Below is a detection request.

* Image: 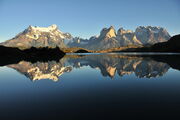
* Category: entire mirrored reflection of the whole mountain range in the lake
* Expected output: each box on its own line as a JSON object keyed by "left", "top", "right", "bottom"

{"left": 7, "top": 55, "right": 170, "bottom": 81}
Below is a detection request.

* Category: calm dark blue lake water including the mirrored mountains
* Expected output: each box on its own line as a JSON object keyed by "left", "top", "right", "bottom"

{"left": 0, "top": 54, "right": 180, "bottom": 120}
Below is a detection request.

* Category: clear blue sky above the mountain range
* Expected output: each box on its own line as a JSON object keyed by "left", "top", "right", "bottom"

{"left": 0, "top": 0, "right": 180, "bottom": 41}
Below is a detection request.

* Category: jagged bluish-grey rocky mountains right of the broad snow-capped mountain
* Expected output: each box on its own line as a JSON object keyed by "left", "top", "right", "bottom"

{"left": 68, "top": 26, "right": 171, "bottom": 50}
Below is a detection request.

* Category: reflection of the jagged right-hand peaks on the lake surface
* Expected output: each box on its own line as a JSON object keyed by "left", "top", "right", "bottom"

{"left": 68, "top": 55, "right": 170, "bottom": 78}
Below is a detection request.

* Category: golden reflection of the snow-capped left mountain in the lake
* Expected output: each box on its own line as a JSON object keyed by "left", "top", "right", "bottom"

{"left": 8, "top": 61, "right": 72, "bottom": 81}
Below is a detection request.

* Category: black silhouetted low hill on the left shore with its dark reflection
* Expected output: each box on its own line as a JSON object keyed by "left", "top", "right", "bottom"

{"left": 0, "top": 46, "right": 65, "bottom": 66}
